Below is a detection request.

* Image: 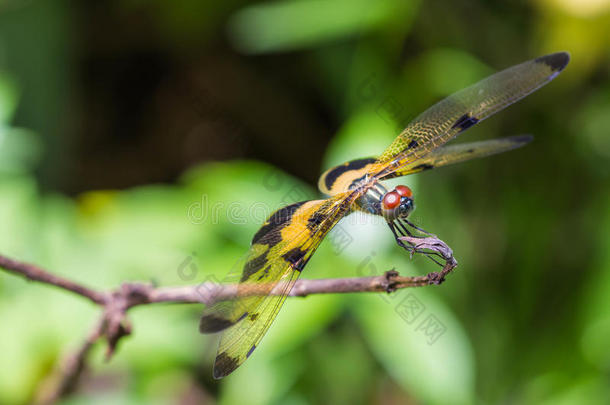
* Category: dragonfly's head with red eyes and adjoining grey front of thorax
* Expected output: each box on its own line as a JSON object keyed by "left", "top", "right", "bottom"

{"left": 357, "top": 183, "right": 415, "bottom": 221}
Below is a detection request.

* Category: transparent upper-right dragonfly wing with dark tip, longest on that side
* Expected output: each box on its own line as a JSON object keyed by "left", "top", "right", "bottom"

{"left": 372, "top": 52, "right": 570, "bottom": 179}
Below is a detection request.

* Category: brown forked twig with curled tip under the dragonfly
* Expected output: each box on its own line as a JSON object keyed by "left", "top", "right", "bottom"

{"left": 0, "top": 236, "right": 457, "bottom": 404}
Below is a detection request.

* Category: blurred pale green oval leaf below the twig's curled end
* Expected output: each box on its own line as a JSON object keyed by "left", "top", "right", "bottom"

{"left": 354, "top": 289, "right": 475, "bottom": 404}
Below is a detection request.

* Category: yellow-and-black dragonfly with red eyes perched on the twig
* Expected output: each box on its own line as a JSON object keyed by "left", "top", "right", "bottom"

{"left": 199, "top": 52, "right": 570, "bottom": 379}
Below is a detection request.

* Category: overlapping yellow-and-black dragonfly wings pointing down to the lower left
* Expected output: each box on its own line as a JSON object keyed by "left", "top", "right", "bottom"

{"left": 199, "top": 193, "right": 357, "bottom": 378}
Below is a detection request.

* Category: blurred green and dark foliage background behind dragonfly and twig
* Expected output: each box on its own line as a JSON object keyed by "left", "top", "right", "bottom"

{"left": 0, "top": 0, "right": 610, "bottom": 405}
